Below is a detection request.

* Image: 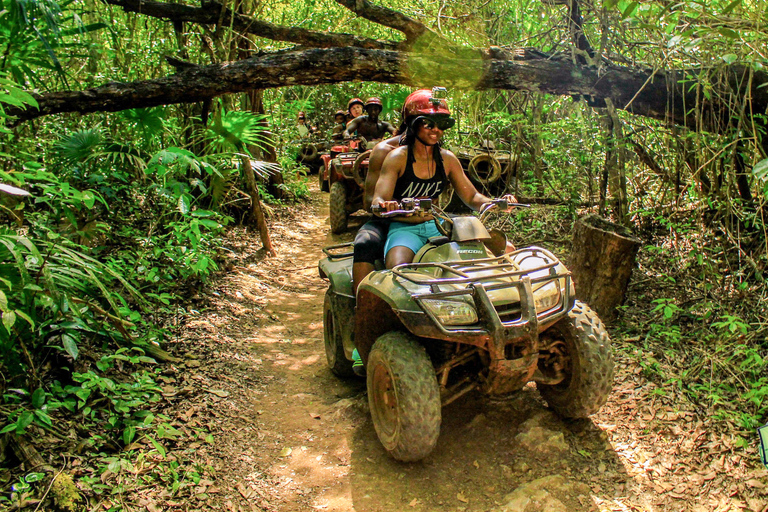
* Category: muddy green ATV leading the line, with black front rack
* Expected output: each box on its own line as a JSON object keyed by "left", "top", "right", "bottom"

{"left": 319, "top": 200, "right": 613, "bottom": 461}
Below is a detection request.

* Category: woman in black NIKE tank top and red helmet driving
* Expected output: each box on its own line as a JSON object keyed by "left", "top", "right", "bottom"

{"left": 372, "top": 87, "right": 517, "bottom": 268}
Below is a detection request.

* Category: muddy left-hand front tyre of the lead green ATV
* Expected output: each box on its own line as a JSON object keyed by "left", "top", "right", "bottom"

{"left": 366, "top": 331, "right": 441, "bottom": 461}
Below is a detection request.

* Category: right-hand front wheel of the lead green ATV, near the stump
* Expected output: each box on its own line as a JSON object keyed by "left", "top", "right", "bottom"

{"left": 537, "top": 301, "right": 613, "bottom": 418}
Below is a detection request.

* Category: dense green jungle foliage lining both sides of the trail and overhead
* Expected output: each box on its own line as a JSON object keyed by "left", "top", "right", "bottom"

{"left": 0, "top": 0, "right": 768, "bottom": 501}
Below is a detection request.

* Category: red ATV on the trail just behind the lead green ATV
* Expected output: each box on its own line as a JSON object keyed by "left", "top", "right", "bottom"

{"left": 320, "top": 137, "right": 378, "bottom": 234}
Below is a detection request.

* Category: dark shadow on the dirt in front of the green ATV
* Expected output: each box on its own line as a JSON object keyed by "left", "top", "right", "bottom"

{"left": 350, "top": 387, "right": 628, "bottom": 512}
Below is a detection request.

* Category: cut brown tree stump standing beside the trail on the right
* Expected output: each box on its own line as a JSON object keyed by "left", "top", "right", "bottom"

{"left": 570, "top": 215, "right": 641, "bottom": 321}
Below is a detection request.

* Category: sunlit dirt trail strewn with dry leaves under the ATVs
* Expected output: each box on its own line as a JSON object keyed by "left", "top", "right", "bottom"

{"left": 166, "top": 183, "right": 768, "bottom": 512}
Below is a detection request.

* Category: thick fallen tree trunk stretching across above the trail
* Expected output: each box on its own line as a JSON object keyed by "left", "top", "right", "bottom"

{"left": 7, "top": 47, "right": 768, "bottom": 147}
